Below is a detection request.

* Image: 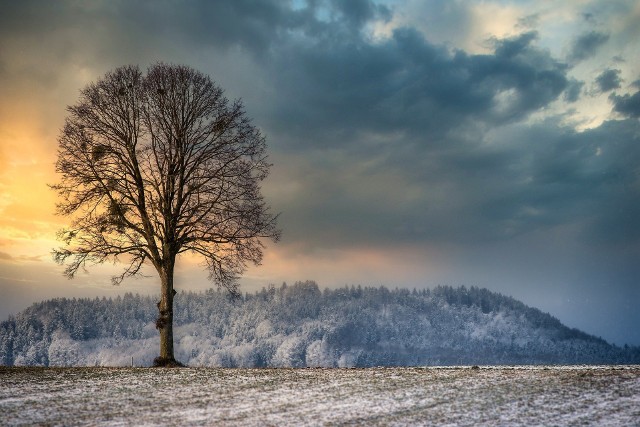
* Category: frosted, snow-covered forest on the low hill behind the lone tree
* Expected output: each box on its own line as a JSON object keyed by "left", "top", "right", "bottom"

{"left": 0, "top": 282, "right": 640, "bottom": 367}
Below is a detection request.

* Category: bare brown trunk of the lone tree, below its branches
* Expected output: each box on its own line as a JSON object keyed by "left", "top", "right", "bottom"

{"left": 153, "top": 259, "right": 182, "bottom": 366}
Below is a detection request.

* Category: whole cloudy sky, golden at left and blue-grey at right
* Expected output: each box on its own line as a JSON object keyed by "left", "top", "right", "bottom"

{"left": 0, "top": 0, "right": 640, "bottom": 345}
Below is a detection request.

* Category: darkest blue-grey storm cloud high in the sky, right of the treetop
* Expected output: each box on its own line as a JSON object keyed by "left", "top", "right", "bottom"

{"left": 274, "top": 28, "right": 569, "bottom": 149}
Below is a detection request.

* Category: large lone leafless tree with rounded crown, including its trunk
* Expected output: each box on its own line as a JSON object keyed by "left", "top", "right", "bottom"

{"left": 52, "top": 63, "right": 280, "bottom": 366}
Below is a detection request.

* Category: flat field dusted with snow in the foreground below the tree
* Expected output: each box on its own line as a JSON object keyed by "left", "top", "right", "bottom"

{"left": 0, "top": 366, "right": 640, "bottom": 426}
